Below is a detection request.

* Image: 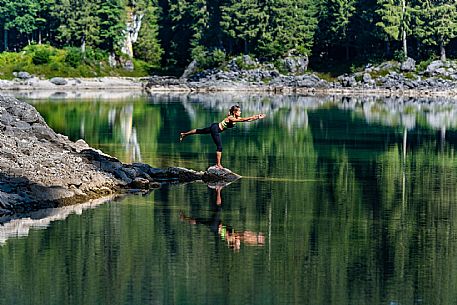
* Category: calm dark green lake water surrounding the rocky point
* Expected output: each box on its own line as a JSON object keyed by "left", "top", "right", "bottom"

{"left": 0, "top": 94, "right": 457, "bottom": 305}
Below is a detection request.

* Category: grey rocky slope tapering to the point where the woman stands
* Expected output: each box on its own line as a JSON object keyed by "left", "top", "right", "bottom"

{"left": 0, "top": 94, "right": 240, "bottom": 216}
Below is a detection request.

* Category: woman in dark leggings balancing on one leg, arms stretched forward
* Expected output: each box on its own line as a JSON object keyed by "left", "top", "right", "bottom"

{"left": 179, "top": 105, "right": 265, "bottom": 168}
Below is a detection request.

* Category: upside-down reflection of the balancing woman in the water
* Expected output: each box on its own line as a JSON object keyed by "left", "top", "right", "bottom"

{"left": 179, "top": 184, "right": 265, "bottom": 250}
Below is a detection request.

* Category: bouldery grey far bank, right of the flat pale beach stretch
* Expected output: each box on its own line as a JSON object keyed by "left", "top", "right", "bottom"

{"left": 145, "top": 57, "right": 457, "bottom": 97}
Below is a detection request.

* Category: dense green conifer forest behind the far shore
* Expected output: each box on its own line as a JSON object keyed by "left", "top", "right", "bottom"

{"left": 0, "top": 0, "right": 457, "bottom": 73}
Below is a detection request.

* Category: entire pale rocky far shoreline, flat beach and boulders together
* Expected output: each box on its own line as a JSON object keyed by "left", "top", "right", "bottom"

{"left": 4, "top": 55, "right": 457, "bottom": 98}
